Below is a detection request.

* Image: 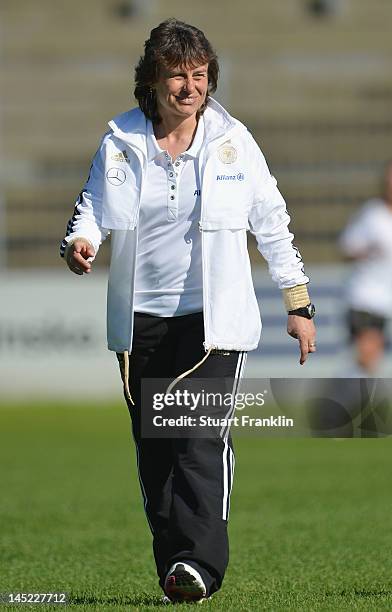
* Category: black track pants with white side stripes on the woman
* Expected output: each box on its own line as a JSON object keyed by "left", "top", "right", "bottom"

{"left": 118, "top": 313, "right": 246, "bottom": 594}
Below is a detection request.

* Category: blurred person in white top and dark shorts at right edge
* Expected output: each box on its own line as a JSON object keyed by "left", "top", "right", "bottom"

{"left": 340, "top": 163, "right": 392, "bottom": 377}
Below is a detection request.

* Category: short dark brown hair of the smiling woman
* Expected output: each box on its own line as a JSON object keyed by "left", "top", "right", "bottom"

{"left": 134, "top": 18, "right": 219, "bottom": 123}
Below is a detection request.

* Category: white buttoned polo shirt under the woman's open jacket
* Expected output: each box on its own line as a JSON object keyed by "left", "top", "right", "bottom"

{"left": 135, "top": 117, "right": 204, "bottom": 317}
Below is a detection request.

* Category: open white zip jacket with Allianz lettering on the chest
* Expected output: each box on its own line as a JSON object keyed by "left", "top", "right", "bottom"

{"left": 62, "top": 98, "right": 309, "bottom": 352}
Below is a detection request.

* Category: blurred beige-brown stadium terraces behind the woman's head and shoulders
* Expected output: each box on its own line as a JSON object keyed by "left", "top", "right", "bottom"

{"left": 0, "top": 0, "right": 392, "bottom": 268}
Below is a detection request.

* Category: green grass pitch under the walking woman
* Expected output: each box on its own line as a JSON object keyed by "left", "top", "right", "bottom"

{"left": 0, "top": 406, "right": 392, "bottom": 612}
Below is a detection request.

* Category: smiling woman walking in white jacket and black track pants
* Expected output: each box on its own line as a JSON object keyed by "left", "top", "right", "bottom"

{"left": 62, "top": 19, "right": 315, "bottom": 601}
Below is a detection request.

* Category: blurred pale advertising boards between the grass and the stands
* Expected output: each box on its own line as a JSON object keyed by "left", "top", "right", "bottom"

{"left": 0, "top": 265, "right": 392, "bottom": 403}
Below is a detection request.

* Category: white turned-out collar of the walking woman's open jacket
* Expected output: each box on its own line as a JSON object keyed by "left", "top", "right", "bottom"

{"left": 109, "top": 97, "right": 246, "bottom": 155}
